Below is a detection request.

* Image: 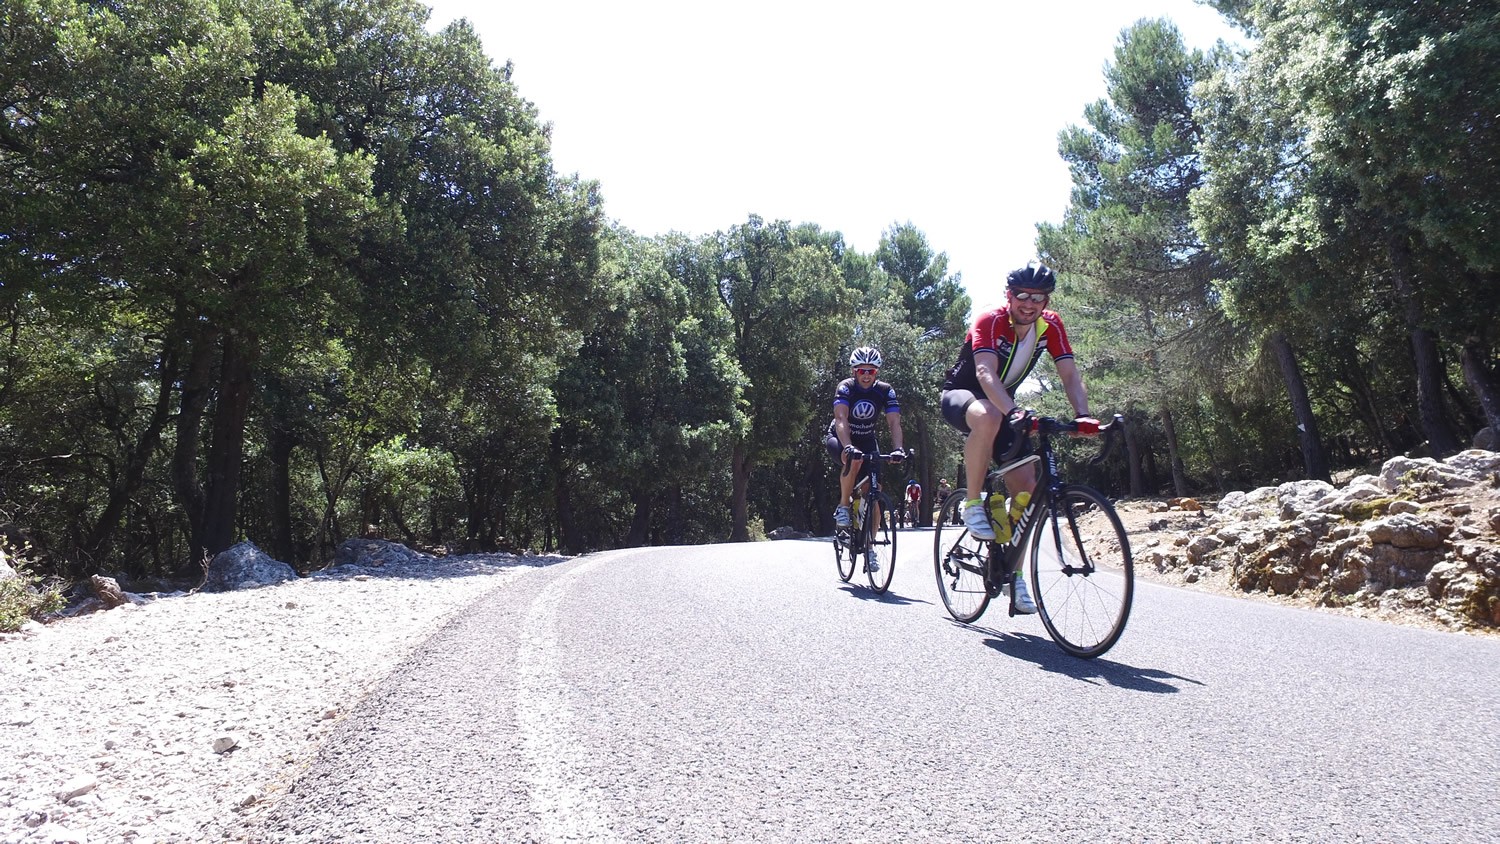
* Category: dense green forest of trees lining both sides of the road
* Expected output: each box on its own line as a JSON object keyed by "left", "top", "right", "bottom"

{"left": 0, "top": 0, "right": 1500, "bottom": 579}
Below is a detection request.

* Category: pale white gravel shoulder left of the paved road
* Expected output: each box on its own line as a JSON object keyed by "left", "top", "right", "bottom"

{"left": 0, "top": 555, "right": 563, "bottom": 844}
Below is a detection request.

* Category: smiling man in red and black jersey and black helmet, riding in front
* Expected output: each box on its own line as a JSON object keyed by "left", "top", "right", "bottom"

{"left": 942, "top": 262, "right": 1098, "bottom": 613}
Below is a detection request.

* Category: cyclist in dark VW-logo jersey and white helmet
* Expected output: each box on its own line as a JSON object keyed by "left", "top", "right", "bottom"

{"left": 824, "top": 346, "right": 906, "bottom": 528}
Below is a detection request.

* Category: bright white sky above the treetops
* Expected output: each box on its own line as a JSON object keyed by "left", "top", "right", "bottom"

{"left": 428, "top": 0, "right": 1242, "bottom": 307}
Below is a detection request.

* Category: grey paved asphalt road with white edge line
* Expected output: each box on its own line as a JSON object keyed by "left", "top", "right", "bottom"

{"left": 251, "top": 531, "right": 1500, "bottom": 843}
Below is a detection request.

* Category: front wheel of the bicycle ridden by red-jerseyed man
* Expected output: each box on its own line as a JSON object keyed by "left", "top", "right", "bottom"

{"left": 1031, "top": 484, "right": 1136, "bottom": 660}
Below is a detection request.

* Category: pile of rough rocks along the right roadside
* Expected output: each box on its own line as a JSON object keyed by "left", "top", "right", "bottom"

{"left": 1122, "top": 450, "right": 1500, "bottom": 631}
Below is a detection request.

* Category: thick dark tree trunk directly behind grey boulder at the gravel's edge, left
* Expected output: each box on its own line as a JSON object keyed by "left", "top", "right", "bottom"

{"left": 203, "top": 331, "right": 258, "bottom": 555}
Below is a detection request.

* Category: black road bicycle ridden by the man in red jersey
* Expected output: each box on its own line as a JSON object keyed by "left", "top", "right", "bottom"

{"left": 933, "top": 414, "right": 1136, "bottom": 658}
